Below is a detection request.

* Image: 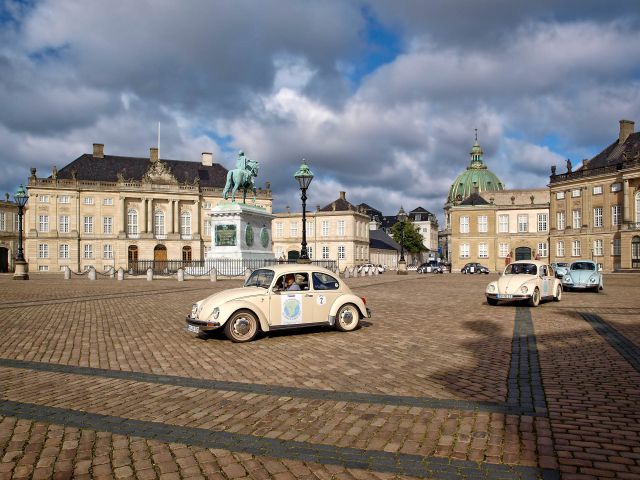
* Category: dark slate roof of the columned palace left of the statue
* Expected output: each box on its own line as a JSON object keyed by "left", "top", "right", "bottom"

{"left": 58, "top": 153, "right": 227, "bottom": 188}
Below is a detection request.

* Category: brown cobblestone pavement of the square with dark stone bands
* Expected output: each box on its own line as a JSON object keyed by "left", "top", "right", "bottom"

{"left": 0, "top": 274, "right": 640, "bottom": 480}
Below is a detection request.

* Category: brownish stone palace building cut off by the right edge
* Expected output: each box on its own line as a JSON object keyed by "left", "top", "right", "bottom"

{"left": 549, "top": 120, "right": 640, "bottom": 272}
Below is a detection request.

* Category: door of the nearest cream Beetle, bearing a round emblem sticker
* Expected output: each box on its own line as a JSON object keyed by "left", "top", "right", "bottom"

{"left": 269, "top": 272, "right": 315, "bottom": 328}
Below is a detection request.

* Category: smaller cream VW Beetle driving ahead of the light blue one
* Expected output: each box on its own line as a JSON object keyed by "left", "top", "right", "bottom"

{"left": 485, "top": 260, "right": 562, "bottom": 307}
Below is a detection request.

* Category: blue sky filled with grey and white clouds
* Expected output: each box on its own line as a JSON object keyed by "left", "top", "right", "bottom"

{"left": 0, "top": 0, "right": 640, "bottom": 216}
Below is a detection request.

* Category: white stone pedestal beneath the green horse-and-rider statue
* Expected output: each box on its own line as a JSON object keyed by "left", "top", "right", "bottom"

{"left": 205, "top": 203, "right": 275, "bottom": 260}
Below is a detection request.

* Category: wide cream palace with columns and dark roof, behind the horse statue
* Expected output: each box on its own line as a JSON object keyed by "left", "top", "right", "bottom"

{"left": 24, "top": 144, "right": 272, "bottom": 272}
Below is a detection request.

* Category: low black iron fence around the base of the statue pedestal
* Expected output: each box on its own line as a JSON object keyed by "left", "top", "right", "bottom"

{"left": 127, "top": 258, "right": 337, "bottom": 277}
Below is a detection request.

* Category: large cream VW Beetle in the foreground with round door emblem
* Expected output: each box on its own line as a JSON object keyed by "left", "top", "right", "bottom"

{"left": 186, "top": 264, "right": 371, "bottom": 342}
